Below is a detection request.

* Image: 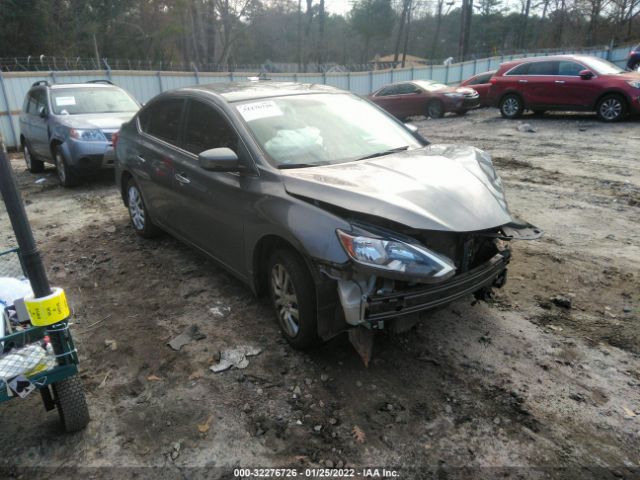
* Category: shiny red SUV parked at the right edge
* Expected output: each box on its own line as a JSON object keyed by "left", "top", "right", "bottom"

{"left": 489, "top": 55, "right": 640, "bottom": 122}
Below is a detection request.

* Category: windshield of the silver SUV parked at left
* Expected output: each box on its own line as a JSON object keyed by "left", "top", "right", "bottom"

{"left": 51, "top": 87, "right": 138, "bottom": 115}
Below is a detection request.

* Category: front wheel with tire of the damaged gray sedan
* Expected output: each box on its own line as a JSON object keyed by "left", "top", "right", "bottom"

{"left": 267, "top": 250, "right": 320, "bottom": 350}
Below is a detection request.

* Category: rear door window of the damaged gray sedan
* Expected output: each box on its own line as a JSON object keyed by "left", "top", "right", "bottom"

{"left": 138, "top": 98, "right": 185, "bottom": 145}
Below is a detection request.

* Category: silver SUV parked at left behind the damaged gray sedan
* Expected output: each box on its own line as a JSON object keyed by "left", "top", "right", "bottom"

{"left": 20, "top": 80, "right": 140, "bottom": 187}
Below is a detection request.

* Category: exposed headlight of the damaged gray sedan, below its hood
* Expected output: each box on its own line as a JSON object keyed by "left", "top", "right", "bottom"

{"left": 336, "top": 229, "right": 456, "bottom": 280}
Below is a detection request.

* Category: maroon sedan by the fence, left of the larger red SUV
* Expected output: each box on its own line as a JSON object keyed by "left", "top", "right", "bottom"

{"left": 368, "top": 80, "right": 480, "bottom": 120}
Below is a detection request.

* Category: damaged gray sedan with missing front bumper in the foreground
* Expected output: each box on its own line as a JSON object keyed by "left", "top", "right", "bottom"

{"left": 114, "top": 82, "right": 541, "bottom": 362}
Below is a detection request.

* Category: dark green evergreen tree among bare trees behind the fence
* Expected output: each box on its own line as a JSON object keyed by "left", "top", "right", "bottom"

{"left": 351, "top": 0, "right": 395, "bottom": 62}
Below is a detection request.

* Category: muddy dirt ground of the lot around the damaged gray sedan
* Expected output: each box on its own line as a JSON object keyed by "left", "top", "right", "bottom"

{"left": 0, "top": 110, "right": 640, "bottom": 479}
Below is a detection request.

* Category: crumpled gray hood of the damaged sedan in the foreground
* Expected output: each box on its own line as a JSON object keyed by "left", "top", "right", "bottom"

{"left": 282, "top": 145, "right": 515, "bottom": 232}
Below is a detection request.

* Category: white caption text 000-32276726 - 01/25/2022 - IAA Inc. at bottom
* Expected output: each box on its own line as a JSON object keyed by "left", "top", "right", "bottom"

{"left": 233, "top": 468, "right": 399, "bottom": 479}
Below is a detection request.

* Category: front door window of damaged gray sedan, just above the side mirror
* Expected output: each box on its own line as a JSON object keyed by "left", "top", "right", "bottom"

{"left": 182, "top": 100, "right": 238, "bottom": 155}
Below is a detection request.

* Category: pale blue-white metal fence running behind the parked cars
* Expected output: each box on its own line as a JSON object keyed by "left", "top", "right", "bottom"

{"left": 0, "top": 46, "right": 629, "bottom": 147}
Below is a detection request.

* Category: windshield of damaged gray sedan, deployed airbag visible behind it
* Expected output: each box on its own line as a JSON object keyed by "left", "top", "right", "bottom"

{"left": 236, "top": 93, "right": 422, "bottom": 168}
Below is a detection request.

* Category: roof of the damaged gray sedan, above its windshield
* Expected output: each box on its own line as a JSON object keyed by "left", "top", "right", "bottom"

{"left": 172, "top": 80, "right": 348, "bottom": 102}
